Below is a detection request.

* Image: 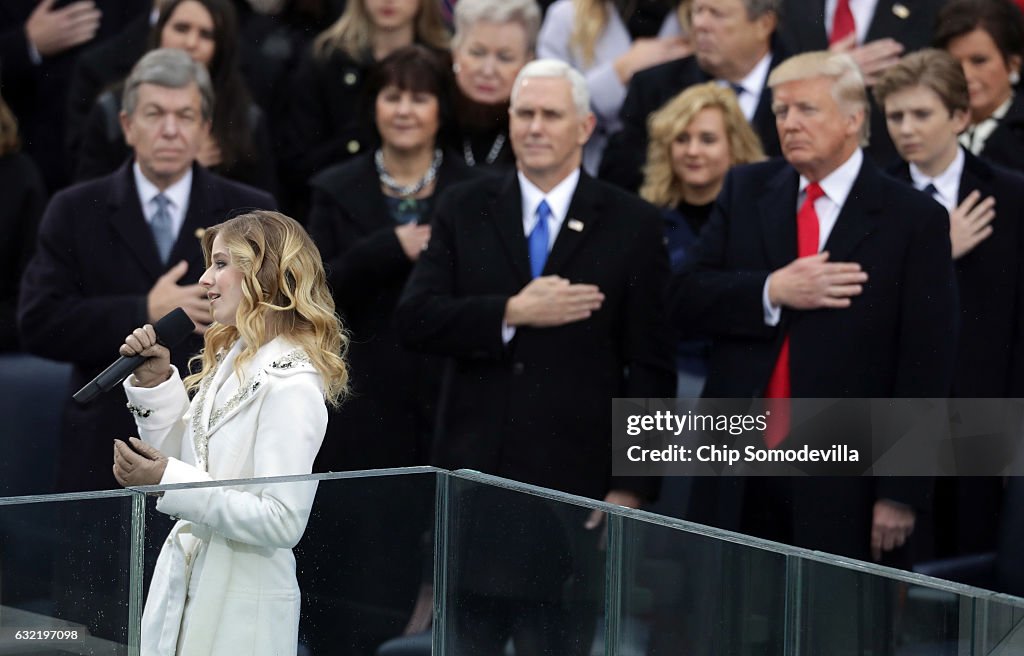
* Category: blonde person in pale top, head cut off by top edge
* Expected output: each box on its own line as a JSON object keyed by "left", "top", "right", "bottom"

{"left": 537, "top": 0, "right": 692, "bottom": 175}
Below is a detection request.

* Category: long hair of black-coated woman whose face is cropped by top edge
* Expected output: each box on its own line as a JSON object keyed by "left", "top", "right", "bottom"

{"left": 313, "top": 0, "right": 451, "bottom": 61}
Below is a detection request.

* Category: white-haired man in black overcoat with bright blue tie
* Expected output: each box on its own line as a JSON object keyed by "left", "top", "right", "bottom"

{"left": 397, "top": 59, "right": 675, "bottom": 654}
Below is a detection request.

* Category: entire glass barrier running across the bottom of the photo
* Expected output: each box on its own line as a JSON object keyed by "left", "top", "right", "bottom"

{"left": 0, "top": 468, "right": 1024, "bottom": 656}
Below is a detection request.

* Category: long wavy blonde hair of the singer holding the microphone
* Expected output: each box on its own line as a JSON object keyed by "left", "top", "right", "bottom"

{"left": 184, "top": 210, "right": 348, "bottom": 406}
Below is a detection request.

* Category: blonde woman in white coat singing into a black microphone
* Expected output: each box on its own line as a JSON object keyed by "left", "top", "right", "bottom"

{"left": 114, "top": 211, "right": 348, "bottom": 656}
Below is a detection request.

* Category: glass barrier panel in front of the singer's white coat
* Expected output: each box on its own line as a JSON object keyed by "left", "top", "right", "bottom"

{"left": 140, "top": 468, "right": 437, "bottom": 656}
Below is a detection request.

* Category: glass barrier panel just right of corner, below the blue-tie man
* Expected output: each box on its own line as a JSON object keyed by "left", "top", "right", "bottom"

{"left": 440, "top": 477, "right": 606, "bottom": 656}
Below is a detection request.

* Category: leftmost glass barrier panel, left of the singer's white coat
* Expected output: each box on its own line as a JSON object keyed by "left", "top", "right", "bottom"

{"left": 0, "top": 490, "right": 140, "bottom": 656}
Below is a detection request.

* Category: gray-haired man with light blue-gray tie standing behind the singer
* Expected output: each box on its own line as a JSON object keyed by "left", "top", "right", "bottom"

{"left": 18, "top": 48, "right": 275, "bottom": 491}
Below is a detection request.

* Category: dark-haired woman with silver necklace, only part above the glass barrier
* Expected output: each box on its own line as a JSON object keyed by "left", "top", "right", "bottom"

{"left": 309, "top": 45, "right": 469, "bottom": 470}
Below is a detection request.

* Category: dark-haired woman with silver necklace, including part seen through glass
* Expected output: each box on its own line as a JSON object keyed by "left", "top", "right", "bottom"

{"left": 302, "top": 45, "right": 471, "bottom": 654}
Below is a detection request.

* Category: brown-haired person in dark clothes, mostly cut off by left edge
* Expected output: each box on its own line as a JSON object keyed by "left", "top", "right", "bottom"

{"left": 0, "top": 98, "right": 46, "bottom": 352}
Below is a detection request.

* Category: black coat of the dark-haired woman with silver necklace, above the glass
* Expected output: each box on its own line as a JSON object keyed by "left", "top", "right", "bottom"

{"left": 309, "top": 154, "right": 473, "bottom": 471}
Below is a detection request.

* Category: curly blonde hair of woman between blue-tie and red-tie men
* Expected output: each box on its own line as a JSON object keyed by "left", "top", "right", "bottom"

{"left": 640, "top": 82, "right": 765, "bottom": 208}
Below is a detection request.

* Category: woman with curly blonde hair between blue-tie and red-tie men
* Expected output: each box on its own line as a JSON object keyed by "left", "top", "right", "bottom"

{"left": 640, "top": 82, "right": 765, "bottom": 390}
